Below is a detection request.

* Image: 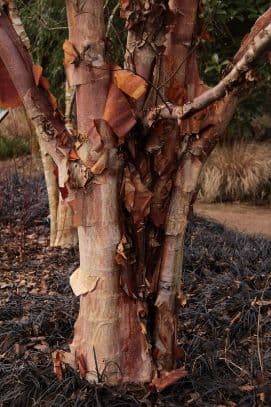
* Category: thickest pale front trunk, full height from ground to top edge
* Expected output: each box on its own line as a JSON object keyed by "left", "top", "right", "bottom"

{"left": 62, "top": 0, "right": 153, "bottom": 383}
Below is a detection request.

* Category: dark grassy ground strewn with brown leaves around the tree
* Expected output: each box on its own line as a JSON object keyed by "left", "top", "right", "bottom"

{"left": 0, "top": 175, "right": 271, "bottom": 407}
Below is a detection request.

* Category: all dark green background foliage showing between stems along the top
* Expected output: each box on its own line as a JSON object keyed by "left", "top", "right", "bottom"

{"left": 13, "top": 0, "right": 271, "bottom": 138}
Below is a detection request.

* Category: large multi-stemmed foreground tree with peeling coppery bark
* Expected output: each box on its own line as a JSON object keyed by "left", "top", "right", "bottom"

{"left": 0, "top": 0, "right": 271, "bottom": 389}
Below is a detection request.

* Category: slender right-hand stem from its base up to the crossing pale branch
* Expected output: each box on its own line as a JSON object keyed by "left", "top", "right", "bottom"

{"left": 154, "top": 95, "right": 237, "bottom": 371}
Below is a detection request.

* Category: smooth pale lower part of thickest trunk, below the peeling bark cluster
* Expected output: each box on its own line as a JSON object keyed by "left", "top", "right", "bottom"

{"left": 65, "top": 175, "right": 152, "bottom": 384}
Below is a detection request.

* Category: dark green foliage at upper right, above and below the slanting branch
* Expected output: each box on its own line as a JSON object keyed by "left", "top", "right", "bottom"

{"left": 199, "top": 0, "right": 271, "bottom": 140}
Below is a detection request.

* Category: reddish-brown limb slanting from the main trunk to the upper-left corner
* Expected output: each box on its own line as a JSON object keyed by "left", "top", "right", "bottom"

{"left": 0, "top": 12, "right": 69, "bottom": 169}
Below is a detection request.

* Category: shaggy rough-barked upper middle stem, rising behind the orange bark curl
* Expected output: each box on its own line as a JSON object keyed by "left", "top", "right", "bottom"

{"left": 121, "top": 0, "right": 167, "bottom": 109}
